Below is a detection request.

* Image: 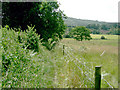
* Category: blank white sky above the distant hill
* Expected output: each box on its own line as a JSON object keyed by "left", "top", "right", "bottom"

{"left": 57, "top": 0, "right": 120, "bottom": 22}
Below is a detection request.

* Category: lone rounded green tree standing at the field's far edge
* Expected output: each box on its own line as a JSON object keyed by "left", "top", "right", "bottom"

{"left": 70, "top": 26, "right": 92, "bottom": 41}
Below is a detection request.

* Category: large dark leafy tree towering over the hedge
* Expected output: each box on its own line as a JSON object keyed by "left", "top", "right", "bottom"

{"left": 2, "top": 2, "right": 66, "bottom": 48}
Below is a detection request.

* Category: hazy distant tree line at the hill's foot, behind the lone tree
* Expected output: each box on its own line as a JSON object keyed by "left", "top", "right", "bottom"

{"left": 66, "top": 23, "right": 119, "bottom": 35}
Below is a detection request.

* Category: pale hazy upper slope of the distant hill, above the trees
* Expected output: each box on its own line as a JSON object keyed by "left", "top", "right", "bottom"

{"left": 64, "top": 17, "right": 115, "bottom": 26}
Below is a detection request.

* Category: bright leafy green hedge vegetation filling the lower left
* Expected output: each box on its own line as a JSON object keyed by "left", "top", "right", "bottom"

{"left": 1, "top": 26, "right": 54, "bottom": 88}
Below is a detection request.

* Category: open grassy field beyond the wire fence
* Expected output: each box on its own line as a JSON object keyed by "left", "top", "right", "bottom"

{"left": 58, "top": 35, "right": 118, "bottom": 88}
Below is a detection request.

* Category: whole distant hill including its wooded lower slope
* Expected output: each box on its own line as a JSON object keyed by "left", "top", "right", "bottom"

{"left": 64, "top": 17, "right": 118, "bottom": 35}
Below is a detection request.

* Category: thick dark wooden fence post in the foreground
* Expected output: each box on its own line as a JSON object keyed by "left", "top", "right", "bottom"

{"left": 95, "top": 66, "right": 101, "bottom": 90}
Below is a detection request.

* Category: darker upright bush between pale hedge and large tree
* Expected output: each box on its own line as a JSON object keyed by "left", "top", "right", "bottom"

{"left": 18, "top": 26, "right": 40, "bottom": 52}
